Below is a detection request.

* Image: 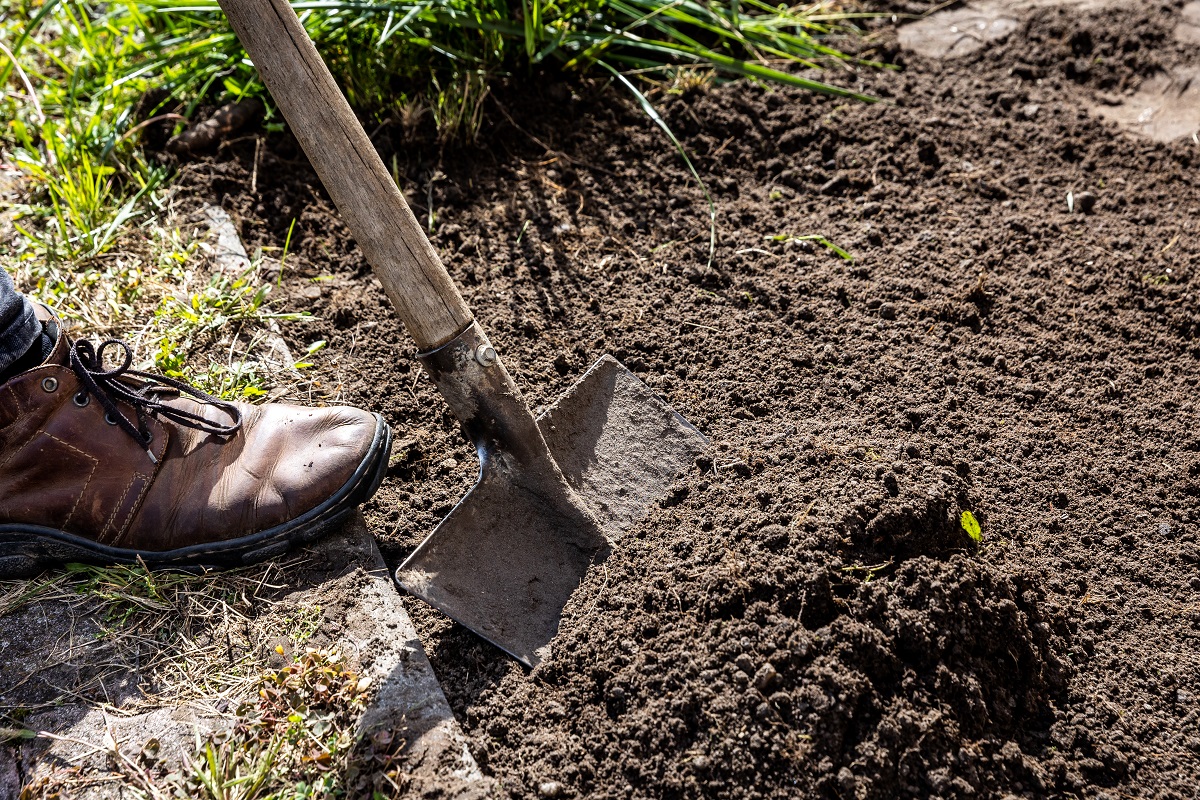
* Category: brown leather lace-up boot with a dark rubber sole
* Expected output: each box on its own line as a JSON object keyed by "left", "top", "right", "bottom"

{"left": 0, "top": 312, "right": 391, "bottom": 578}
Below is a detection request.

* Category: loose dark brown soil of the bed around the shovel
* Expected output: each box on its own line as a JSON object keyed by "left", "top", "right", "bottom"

{"left": 162, "top": 2, "right": 1200, "bottom": 800}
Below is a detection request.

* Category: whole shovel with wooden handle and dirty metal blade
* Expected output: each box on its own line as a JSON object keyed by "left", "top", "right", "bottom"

{"left": 220, "top": 0, "right": 708, "bottom": 667}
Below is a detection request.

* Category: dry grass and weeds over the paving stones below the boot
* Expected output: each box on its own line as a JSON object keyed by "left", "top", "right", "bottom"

{"left": 0, "top": 555, "right": 404, "bottom": 800}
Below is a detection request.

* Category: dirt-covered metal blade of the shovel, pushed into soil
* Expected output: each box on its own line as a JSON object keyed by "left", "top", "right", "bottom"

{"left": 396, "top": 343, "right": 708, "bottom": 667}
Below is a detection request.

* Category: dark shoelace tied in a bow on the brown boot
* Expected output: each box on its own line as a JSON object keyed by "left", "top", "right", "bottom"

{"left": 71, "top": 339, "right": 241, "bottom": 463}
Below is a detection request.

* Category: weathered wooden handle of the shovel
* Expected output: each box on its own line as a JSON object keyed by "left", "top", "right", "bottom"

{"left": 218, "top": 0, "right": 472, "bottom": 350}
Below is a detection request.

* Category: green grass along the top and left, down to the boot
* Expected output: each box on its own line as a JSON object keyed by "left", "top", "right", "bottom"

{"left": 0, "top": 0, "right": 883, "bottom": 388}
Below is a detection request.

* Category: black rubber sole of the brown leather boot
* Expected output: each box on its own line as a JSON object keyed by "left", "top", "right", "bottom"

{"left": 0, "top": 414, "right": 391, "bottom": 579}
